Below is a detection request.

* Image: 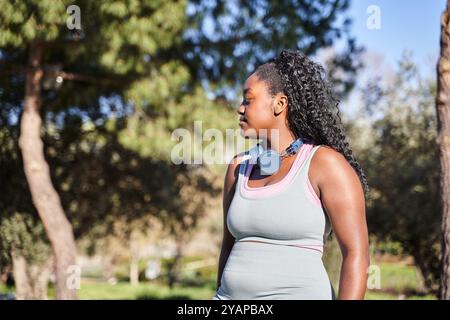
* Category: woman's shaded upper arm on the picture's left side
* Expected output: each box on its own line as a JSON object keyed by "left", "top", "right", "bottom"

{"left": 222, "top": 154, "right": 243, "bottom": 246}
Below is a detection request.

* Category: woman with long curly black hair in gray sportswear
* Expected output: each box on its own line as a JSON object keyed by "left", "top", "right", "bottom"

{"left": 213, "top": 50, "right": 369, "bottom": 300}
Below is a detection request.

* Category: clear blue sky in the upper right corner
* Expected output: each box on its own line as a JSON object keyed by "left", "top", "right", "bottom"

{"left": 349, "top": 0, "right": 446, "bottom": 71}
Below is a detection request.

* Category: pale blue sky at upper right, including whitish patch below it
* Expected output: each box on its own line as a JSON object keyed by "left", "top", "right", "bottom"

{"left": 336, "top": 0, "right": 446, "bottom": 117}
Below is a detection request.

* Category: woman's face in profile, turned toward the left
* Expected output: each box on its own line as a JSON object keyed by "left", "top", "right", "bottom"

{"left": 237, "top": 74, "right": 277, "bottom": 138}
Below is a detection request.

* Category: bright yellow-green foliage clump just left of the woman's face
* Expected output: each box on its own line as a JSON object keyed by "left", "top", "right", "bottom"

{"left": 119, "top": 84, "right": 238, "bottom": 163}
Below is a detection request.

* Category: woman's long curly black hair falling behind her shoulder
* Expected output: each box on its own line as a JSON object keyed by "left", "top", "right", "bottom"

{"left": 255, "top": 49, "right": 369, "bottom": 197}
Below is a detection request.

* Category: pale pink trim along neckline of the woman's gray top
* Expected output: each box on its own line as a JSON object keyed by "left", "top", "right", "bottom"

{"left": 241, "top": 144, "right": 314, "bottom": 202}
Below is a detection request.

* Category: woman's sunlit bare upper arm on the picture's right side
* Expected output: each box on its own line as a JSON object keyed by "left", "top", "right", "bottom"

{"left": 313, "top": 147, "right": 369, "bottom": 255}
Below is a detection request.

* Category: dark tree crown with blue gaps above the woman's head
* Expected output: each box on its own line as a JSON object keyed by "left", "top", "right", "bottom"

{"left": 179, "top": 0, "right": 362, "bottom": 97}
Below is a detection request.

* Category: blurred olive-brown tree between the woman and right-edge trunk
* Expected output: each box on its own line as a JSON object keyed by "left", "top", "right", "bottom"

{"left": 359, "top": 55, "right": 441, "bottom": 294}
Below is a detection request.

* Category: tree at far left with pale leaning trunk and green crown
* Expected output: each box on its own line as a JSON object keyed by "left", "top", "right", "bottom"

{"left": 0, "top": 1, "right": 184, "bottom": 299}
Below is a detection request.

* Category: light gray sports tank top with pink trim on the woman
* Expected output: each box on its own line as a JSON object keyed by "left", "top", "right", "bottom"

{"left": 227, "top": 143, "right": 331, "bottom": 252}
